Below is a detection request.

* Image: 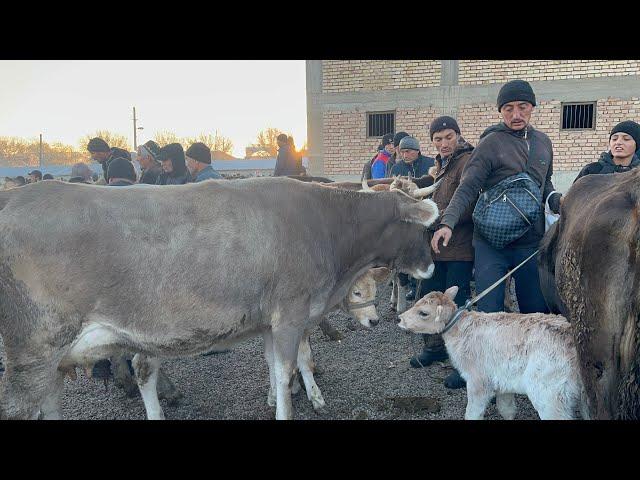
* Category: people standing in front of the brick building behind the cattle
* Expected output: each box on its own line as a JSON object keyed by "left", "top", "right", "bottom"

{"left": 363, "top": 80, "right": 640, "bottom": 388}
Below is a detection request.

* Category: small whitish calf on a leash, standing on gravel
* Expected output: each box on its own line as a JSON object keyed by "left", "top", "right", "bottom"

{"left": 399, "top": 287, "right": 588, "bottom": 420}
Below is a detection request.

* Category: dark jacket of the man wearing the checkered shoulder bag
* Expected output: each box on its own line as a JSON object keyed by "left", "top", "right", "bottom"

{"left": 440, "top": 123, "right": 555, "bottom": 248}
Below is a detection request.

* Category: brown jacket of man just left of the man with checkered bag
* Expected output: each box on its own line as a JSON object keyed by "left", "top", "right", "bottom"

{"left": 431, "top": 137, "right": 476, "bottom": 262}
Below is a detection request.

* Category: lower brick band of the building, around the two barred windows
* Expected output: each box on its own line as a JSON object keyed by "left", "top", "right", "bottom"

{"left": 323, "top": 97, "right": 640, "bottom": 175}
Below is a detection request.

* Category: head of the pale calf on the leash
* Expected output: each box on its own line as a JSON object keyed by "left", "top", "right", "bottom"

{"left": 398, "top": 287, "right": 458, "bottom": 333}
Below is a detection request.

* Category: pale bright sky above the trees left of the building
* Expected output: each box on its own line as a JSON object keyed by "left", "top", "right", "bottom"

{"left": 0, "top": 60, "right": 307, "bottom": 157}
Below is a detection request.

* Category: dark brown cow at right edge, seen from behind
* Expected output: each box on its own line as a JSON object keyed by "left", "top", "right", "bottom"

{"left": 539, "top": 169, "right": 640, "bottom": 419}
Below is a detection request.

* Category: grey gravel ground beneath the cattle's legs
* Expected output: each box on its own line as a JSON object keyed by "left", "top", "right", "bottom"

{"left": 0, "top": 284, "right": 538, "bottom": 420}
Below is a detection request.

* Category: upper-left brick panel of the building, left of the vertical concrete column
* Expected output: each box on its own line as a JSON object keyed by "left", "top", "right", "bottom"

{"left": 322, "top": 60, "right": 440, "bottom": 93}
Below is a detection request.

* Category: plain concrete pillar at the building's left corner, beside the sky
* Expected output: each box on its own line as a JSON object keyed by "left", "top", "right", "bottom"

{"left": 306, "top": 60, "right": 324, "bottom": 175}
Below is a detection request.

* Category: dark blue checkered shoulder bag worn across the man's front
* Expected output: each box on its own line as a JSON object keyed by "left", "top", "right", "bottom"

{"left": 473, "top": 172, "right": 542, "bottom": 250}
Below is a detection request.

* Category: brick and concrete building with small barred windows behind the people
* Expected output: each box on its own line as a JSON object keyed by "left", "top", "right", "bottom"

{"left": 307, "top": 60, "right": 640, "bottom": 189}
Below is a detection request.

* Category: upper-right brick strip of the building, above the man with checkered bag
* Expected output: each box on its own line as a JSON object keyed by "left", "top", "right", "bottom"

{"left": 458, "top": 60, "right": 640, "bottom": 85}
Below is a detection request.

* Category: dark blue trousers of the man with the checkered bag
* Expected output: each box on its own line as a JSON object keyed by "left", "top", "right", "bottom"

{"left": 473, "top": 237, "right": 549, "bottom": 313}
